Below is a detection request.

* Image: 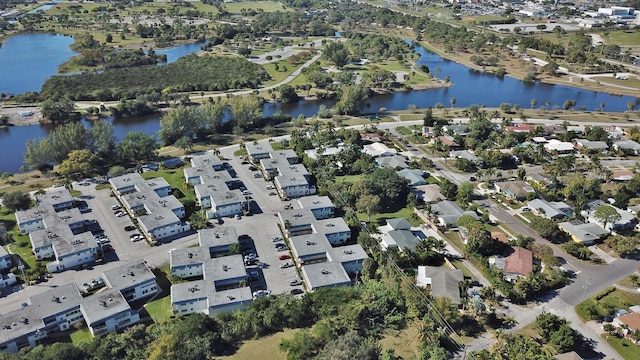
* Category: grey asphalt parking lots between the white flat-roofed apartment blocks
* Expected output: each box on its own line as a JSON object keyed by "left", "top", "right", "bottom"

{"left": 0, "top": 148, "right": 302, "bottom": 311}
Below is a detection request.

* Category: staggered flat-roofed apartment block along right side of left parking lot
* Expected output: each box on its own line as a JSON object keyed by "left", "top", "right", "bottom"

{"left": 109, "top": 173, "right": 191, "bottom": 241}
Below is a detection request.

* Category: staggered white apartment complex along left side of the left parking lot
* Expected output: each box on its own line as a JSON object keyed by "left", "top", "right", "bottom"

{"left": 16, "top": 188, "right": 98, "bottom": 272}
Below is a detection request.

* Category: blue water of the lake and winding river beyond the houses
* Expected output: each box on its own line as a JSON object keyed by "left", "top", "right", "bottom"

{"left": 0, "top": 34, "right": 637, "bottom": 172}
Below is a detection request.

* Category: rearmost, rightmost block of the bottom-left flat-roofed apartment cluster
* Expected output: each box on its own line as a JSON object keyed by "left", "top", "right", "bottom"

{"left": 102, "top": 259, "right": 160, "bottom": 302}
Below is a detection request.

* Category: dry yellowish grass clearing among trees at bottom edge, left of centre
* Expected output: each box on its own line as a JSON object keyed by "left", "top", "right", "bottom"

{"left": 216, "top": 329, "right": 300, "bottom": 360}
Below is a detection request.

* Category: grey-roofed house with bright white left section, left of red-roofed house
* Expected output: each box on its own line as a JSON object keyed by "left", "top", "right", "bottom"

{"left": 416, "top": 266, "right": 464, "bottom": 305}
